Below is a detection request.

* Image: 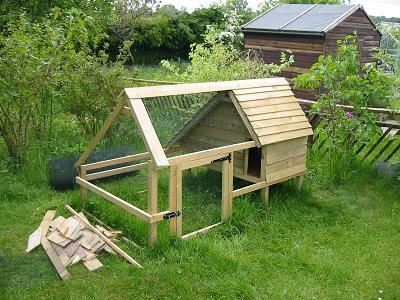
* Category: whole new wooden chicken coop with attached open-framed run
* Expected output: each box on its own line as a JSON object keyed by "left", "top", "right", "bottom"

{"left": 76, "top": 77, "right": 313, "bottom": 244}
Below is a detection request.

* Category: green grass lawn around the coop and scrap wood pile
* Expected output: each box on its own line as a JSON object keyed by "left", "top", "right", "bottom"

{"left": 0, "top": 165, "right": 400, "bottom": 299}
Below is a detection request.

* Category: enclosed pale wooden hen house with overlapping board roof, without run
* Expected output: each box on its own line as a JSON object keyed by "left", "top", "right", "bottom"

{"left": 167, "top": 78, "right": 313, "bottom": 185}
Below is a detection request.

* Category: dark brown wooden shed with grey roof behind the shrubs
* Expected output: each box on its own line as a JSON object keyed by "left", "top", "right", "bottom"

{"left": 242, "top": 4, "right": 382, "bottom": 98}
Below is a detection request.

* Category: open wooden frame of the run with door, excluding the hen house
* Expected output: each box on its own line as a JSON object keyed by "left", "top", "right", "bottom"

{"left": 76, "top": 78, "right": 304, "bottom": 245}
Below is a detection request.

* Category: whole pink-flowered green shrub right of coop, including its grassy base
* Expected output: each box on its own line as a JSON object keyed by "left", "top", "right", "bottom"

{"left": 294, "top": 36, "right": 393, "bottom": 183}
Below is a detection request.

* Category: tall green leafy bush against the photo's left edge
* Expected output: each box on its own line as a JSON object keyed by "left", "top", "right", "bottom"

{"left": 0, "top": 16, "right": 62, "bottom": 163}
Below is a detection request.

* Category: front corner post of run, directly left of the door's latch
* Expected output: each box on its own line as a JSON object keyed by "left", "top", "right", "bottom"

{"left": 147, "top": 162, "right": 158, "bottom": 246}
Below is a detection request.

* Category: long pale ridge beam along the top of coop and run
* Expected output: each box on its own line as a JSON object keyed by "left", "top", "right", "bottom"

{"left": 124, "top": 77, "right": 286, "bottom": 99}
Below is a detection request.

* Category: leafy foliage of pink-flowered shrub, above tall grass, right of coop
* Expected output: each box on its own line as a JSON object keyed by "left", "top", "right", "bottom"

{"left": 294, "top": 36, "right": 393, "bottom": 151}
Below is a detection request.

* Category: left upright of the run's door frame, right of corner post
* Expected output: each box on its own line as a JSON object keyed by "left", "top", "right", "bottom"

{"left": 169, "top": 165, "right": 182, "bottom": 238}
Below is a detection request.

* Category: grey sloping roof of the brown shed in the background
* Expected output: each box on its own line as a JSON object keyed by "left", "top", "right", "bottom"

{"left": 243, "top": 4, "right": 362, "bottom": 35}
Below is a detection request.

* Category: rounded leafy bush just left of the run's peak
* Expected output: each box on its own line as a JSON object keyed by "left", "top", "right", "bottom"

{"left": 62, "top": 47, "right": 125, "bottom": 136}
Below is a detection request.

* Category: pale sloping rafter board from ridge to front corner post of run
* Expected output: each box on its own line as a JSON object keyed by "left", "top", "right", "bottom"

{"left": 128, "top": 99, "right": 169, "bottom": 168}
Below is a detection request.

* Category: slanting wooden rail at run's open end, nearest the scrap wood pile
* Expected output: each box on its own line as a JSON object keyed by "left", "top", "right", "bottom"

{"left": 75, "top": 177, "right": 151, "bottom": 222}
